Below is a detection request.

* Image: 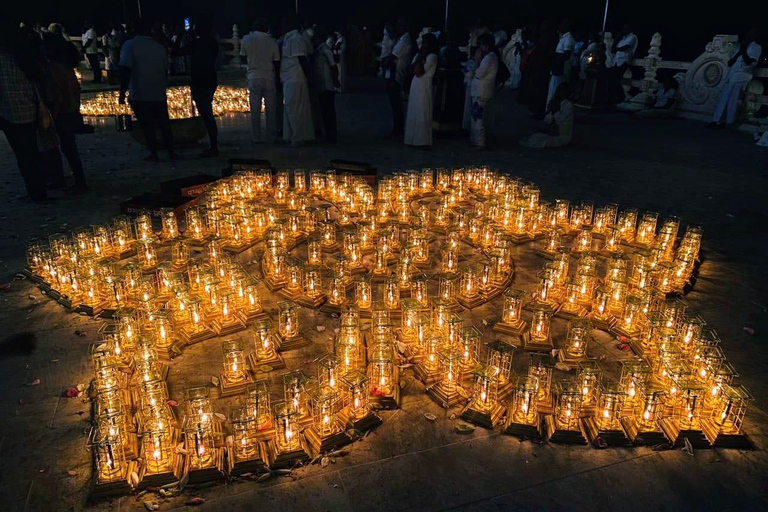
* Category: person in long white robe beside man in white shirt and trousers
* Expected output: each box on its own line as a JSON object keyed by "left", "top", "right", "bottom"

{"left": 280, "top": 17, "right": 315, "bottom": 147}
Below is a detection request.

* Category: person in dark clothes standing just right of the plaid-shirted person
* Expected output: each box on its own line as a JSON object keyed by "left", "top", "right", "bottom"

{"left": 43, "top": 33, "right": 88, "bottom": 193}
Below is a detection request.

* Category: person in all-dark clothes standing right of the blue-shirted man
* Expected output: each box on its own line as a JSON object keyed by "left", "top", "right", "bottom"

{"left": 180, "top": 17, "right": 224, "bottom": 158}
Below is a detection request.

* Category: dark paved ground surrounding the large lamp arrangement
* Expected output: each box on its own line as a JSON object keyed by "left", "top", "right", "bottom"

{"left": 0, "top": 76, "right": 768, "bottom": 511}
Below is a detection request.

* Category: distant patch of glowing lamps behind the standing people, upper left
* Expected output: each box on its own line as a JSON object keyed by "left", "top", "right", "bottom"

{"left": 80, "top": 85, "right": 251, "bottom": 119}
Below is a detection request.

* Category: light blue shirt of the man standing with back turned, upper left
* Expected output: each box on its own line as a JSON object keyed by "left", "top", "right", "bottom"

{"left": 120, "top": 36, "right": 168, "bottom": 101}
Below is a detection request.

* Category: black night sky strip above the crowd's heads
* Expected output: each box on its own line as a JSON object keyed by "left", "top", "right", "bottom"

{"left": 6, "top": 0, "right": 768, "bottom": 60}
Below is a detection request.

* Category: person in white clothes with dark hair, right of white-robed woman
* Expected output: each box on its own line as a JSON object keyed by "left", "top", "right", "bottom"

{"left": 469, "top": 34, "right": 499, "bottom": 149}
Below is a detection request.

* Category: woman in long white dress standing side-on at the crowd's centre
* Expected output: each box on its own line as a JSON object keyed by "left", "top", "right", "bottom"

{"left": 404, "top": 34, "right": 437, "bottom": 146}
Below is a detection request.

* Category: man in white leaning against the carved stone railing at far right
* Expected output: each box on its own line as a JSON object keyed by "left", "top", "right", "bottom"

{"left": 707, "top": 28, "right": 763, "bottom": 128}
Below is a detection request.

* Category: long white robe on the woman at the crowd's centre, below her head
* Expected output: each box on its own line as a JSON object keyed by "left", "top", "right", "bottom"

{"left": 404, "top": 53, "right": 437, "bottom": 146}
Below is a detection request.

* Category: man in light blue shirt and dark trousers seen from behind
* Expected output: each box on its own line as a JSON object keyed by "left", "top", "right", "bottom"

{"left": 119, "top": 20, "right": 176, "bottom": 162}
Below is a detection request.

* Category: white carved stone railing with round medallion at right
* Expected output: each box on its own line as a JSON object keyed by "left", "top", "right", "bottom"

{"left": 605, "top": 32, "right": 768, "bottom": 131}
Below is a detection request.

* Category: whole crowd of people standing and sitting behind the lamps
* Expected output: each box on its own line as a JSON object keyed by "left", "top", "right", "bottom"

{"left": 0, "top": 16, "right": 762, "bottom": 201}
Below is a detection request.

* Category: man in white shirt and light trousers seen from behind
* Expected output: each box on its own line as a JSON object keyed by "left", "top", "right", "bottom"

{"left": 240, "top": 19, "right": 280, "bottom": 143}
